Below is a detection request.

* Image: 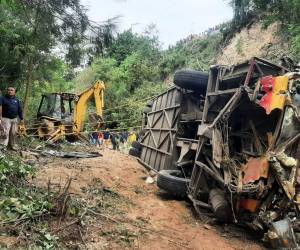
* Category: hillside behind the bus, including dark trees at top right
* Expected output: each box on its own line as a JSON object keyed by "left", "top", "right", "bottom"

{"left": 70, "top": 0, "right": 300, "bottom": 131}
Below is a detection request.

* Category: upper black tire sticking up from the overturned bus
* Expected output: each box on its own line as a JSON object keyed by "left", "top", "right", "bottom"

{"left": 174, "top": 69, "right": 208, "bottom": 95}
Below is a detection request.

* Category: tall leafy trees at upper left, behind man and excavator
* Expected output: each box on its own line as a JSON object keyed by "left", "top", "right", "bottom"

{"left": 0, "top": 0, "right": 116, "bottom": 116}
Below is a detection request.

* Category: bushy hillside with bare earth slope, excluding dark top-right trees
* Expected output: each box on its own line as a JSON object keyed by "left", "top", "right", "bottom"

{"left": 69, "top": 22, "right": 289, "bottom": 131}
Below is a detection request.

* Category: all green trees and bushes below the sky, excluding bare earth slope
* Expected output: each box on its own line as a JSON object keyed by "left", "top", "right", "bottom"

{"left": 0, "top": 0, "right": 300, "bottom": 127}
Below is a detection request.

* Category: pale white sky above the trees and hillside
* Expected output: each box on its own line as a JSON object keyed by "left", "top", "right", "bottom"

{"left": 81, "top": 0, "right": 232, "bottom": 48}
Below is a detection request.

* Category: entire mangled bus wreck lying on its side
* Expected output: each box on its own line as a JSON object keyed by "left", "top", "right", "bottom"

{"left": 139, "top": 58, "right": 300, "bottom": 248}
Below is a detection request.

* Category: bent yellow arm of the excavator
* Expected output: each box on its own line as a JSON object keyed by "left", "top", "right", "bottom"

{"left": 74, "top": 81, "right": 105, "bottom": 133}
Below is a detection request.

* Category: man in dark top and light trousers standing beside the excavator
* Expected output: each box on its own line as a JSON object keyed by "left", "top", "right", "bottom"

{"left": 0, "top": 87, "right": 23, "bottom": 150}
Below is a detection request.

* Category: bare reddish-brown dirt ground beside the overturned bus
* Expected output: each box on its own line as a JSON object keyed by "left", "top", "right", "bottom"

{"left": 32, "top": 149, "right": 263, "bottom": 250}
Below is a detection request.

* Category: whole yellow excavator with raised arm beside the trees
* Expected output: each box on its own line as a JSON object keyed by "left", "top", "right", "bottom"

{"left": 19, "top": 81, "right": 105, "bottom": 142}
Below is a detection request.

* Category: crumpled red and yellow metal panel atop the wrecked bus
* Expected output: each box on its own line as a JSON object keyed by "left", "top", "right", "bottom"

{"left": 259, "top": 76, "right": 289, "bottom": 114}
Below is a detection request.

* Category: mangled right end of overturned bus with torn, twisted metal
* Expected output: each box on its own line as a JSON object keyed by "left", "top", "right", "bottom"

{"left": 189, "top": 67, "right": 300, "bottom": 248}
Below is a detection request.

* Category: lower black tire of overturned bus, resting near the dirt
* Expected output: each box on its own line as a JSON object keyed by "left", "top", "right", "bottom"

{"left": 157, "top": 170, "right": 190, "bottom": 198}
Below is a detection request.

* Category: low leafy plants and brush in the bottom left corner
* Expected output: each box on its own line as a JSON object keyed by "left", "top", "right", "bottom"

{"left": 0, "top": 155, "right": 80, "bottom": 249}
